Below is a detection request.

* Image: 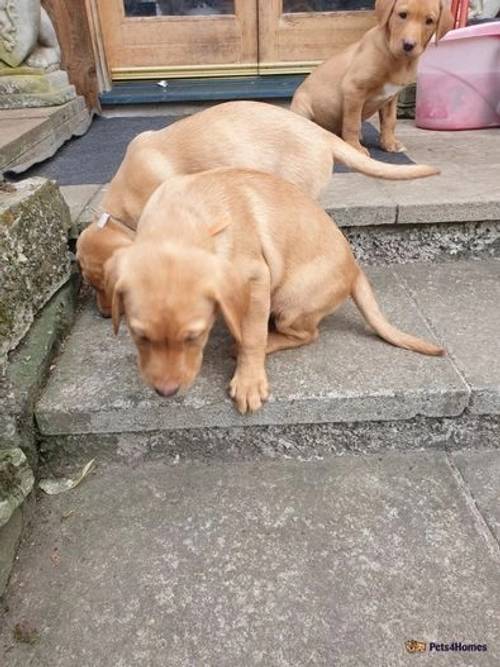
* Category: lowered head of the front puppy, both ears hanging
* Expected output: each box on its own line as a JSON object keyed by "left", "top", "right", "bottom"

{"left": 106, "top": 242, "right": 246, "bottom": 396}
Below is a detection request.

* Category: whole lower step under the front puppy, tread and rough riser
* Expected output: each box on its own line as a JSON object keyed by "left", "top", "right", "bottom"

{"left": 36, "top": 259, "right": 500, "bottom": 468}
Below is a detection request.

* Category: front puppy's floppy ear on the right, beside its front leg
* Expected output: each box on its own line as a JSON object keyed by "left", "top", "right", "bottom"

{"left": 214, "top": 259, "right": 250, "bottom": 343}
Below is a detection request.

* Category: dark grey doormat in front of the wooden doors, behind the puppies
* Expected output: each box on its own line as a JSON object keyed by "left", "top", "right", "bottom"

{"left": 15, "top": 116, "right": 414, "bottom": 185}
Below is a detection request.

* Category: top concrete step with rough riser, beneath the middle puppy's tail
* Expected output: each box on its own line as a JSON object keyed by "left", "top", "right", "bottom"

{"left": 61, "top": 121, "right": 500, "bottom": 264}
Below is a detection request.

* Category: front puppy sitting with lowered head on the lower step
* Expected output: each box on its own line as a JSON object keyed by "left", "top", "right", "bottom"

{"left": 105, "top": 169, "right": 444, "bottom": 413}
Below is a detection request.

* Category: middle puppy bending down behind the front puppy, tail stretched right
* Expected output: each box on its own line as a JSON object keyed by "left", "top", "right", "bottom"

{"left": 77, "top": 102, "right": 439, "bottom": 315}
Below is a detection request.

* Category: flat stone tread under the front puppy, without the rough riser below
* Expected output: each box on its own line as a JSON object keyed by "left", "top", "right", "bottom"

{"left": 36, "top": 259, "right": 500, "bottom": 436}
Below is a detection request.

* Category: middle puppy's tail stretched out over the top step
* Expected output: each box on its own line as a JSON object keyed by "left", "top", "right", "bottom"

{"left": 330, "top": 134, "right": 441, "bottom": 181}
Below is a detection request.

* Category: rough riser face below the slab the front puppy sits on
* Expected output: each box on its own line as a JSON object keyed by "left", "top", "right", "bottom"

{"left": 38, "top": 411, "right": 500, "bottom": 470}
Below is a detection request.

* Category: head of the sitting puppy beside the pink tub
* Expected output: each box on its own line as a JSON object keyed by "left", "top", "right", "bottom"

{"left": 375, "top": 0, "right": 453, "bottom": 59}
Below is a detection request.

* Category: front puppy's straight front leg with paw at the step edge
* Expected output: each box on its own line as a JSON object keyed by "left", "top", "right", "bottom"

{"left": 229, "top": 266, "right": 271, "bottom": 414}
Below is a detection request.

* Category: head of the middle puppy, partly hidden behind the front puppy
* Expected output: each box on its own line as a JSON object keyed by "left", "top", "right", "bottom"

{"left": 76, "top": 222, "right": 132, "bottom": 317}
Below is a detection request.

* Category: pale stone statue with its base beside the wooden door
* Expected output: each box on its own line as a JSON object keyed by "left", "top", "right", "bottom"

{"left": 0, "top": 0, "right": 75, "bottom": 108}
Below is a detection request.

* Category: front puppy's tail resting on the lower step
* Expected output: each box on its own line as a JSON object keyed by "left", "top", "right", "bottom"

{"left": 351, "top": 269, "right": 446, "bottom": 357}
